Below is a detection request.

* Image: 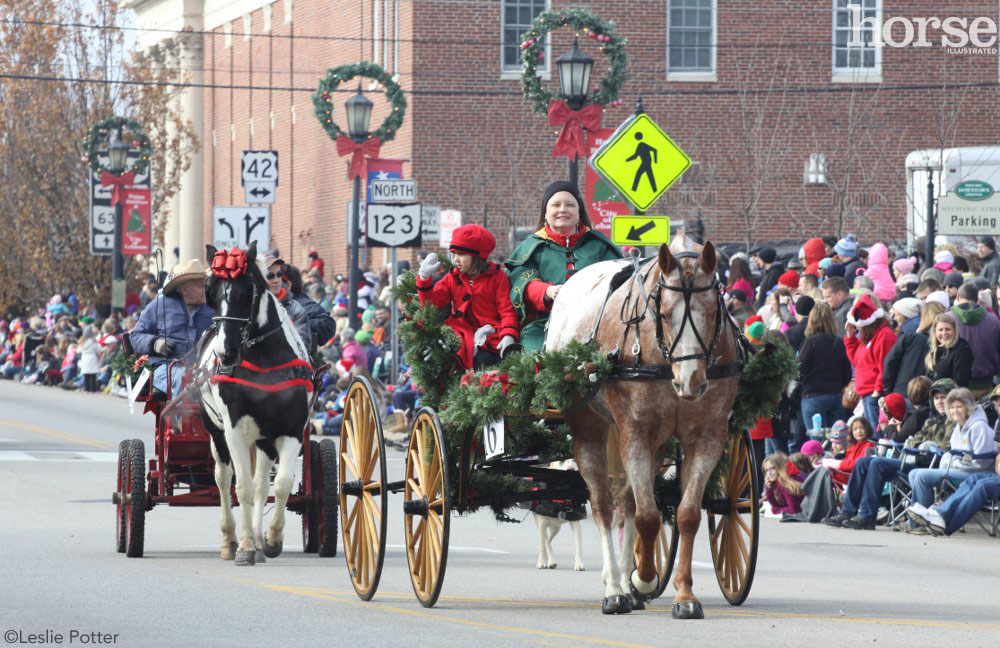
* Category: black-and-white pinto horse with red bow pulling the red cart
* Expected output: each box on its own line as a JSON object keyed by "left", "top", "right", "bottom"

{"left": 198, "top": 243, "right": 313, "bottom": 565}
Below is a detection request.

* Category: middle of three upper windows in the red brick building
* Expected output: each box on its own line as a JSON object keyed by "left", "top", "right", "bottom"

{"left": 667, "top": 0, "right": 715, "bottom": 74}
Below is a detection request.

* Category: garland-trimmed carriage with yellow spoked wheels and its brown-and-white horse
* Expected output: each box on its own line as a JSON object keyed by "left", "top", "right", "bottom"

{"left": 338, "top": 241, "right": 795, "bottom": 618}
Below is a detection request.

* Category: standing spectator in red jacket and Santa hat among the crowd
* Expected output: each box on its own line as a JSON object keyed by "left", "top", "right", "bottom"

{"left": 844, "top": 295, "right": 896, "bottom": 429}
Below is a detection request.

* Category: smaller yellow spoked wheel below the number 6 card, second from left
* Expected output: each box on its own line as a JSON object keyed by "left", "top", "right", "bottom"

{"left": 403, "top": 407, "right": 451, "bottom": 607}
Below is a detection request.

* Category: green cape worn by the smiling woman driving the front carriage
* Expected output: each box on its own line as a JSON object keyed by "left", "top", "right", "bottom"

{"left": 504, "top": 228, "right": 622, "bottom": 351}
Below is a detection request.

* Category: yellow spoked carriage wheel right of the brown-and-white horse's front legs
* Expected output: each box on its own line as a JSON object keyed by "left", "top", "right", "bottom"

{"left": 708, "top": 430, "right": 760, "bottom": 605}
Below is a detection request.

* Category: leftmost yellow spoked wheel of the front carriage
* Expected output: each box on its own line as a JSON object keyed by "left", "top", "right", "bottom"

{"left": 337, "top": 376, "right": 388, "bottom": 601}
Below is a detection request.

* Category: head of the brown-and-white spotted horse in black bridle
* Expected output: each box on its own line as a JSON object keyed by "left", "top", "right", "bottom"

{"left": 657, "top": 236, "right": 722, "bottom": 401}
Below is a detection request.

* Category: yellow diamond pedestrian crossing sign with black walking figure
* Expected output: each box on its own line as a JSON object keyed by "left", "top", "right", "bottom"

{"left": 590, "top": 113, "right": 691, "bottom": 211}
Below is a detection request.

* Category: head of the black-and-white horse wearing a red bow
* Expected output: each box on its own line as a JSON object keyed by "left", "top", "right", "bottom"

{"left": 205, "top": 242, "right": 267, "bottom": 367}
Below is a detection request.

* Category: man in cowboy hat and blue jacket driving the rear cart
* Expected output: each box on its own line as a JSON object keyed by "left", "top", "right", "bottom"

{"left": 129, "top": 259, "right": 215, "bottom": 395}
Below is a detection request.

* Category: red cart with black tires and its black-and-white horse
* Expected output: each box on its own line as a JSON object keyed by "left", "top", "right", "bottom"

{"left": 112, "top": 243, "right": 338, "bottom": 564}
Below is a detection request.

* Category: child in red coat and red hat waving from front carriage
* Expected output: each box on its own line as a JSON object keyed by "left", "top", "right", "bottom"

{"left": 417, "top": 225, "right": 519, "bottom": 369}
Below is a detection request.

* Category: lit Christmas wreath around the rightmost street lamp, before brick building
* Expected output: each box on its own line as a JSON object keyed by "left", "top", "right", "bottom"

{"left": 521, "top": 9, "right": 628, "bottom": 114}
